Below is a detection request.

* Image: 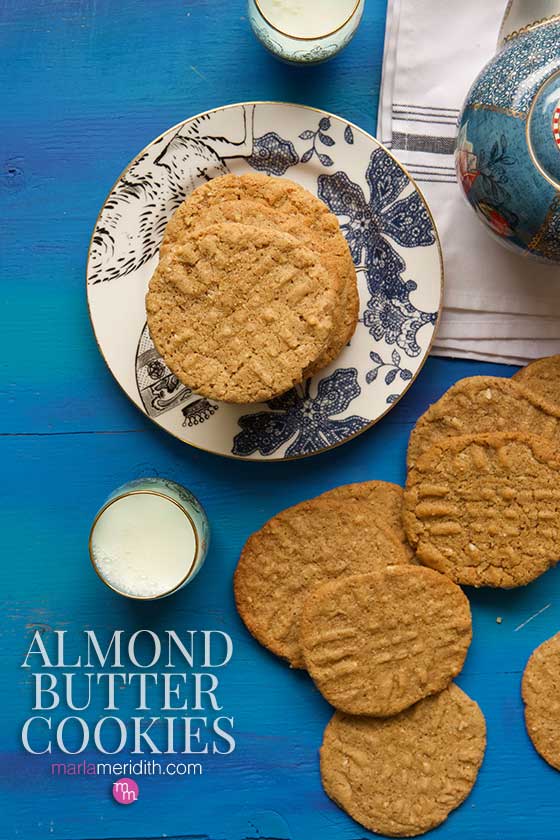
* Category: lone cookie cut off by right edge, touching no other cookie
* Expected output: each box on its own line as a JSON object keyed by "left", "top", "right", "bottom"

{"left": 521, "top": 633, "right": 560, "bottom": 770}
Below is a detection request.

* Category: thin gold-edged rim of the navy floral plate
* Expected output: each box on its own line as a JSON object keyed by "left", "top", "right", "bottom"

{"left": 84, "top": 99, "right": 445, "bottom": 464}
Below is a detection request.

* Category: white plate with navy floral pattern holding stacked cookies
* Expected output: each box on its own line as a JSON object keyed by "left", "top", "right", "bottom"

{"left": 87, "top": 102, "right": 443, "bottom": 460}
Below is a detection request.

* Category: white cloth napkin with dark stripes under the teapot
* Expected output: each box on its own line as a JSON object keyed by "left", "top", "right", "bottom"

{"left": 378, "top": 0, "right": 560, "bottom": 364}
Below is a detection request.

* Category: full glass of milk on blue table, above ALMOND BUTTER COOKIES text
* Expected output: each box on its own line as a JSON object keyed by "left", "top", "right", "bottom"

{"left": 89, "top": 478, "right": 209, "bottom": 600}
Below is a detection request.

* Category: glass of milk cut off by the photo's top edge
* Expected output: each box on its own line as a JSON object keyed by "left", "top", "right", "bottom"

{"left": 248, "top": 0, "right": 364, "bottom": 64}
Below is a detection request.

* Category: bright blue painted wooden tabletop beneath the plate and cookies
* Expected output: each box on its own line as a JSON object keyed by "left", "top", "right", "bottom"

{"left": 0, "top": 0, "right": 560, "bottom": 840}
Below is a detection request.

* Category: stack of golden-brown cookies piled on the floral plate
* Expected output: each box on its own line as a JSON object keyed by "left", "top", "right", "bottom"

{"left": 146, "top": 174, "right": 359, "bottom": 403}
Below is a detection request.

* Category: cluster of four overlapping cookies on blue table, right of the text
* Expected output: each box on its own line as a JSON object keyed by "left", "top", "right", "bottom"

{"left": 234, "top": 481, "right": 486, "bottom": 836}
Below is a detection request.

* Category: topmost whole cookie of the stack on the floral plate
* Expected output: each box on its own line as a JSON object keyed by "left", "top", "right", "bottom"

{"left": 146, "top": 223, "right": 335, "bottom": 403}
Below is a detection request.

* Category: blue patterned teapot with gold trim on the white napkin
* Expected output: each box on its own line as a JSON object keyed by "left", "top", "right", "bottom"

{"left": 455, "top": 0, "right": 560, "bottom": 263}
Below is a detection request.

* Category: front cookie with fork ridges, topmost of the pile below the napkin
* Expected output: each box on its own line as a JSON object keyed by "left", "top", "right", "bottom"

{"left": 403, "top": 432, "right": 560, "bottom": 588}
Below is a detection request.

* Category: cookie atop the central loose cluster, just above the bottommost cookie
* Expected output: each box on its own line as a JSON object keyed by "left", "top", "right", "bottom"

{"left": 300, "top": 566, "right": 472, "bottom": 717}
